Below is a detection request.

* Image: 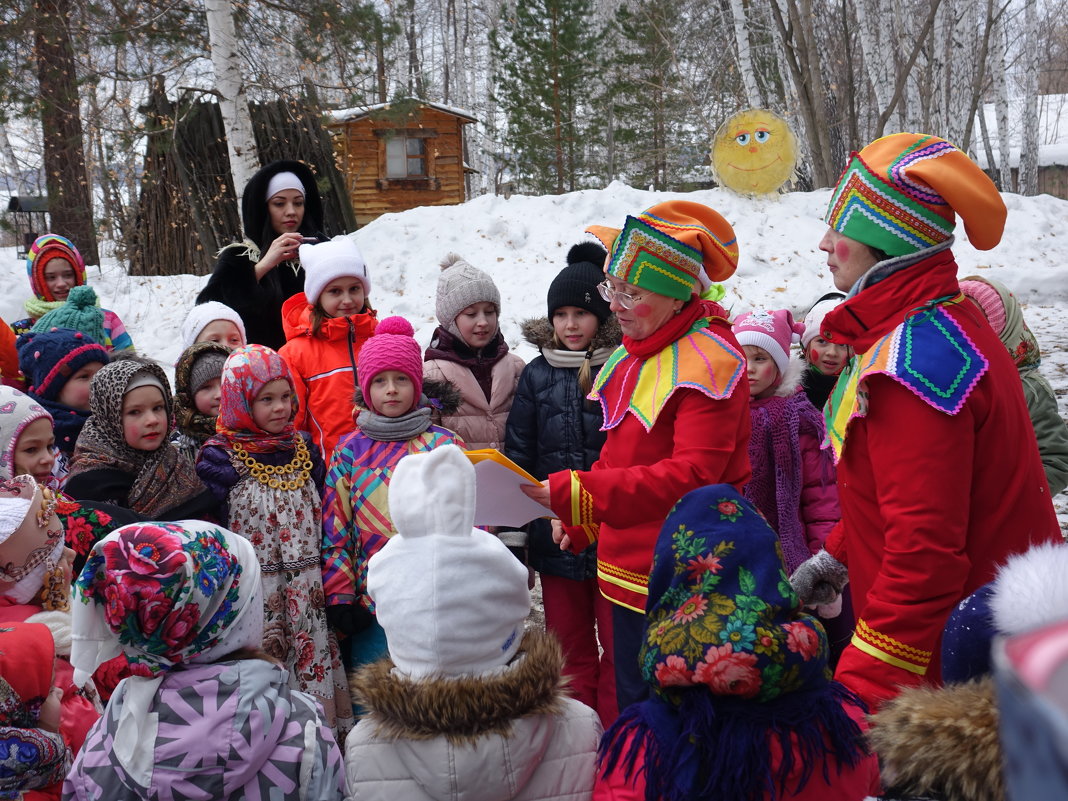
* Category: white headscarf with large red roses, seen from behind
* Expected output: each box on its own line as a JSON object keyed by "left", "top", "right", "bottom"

{"left": 70, "top": 520, "right": 263, "bottom": 684}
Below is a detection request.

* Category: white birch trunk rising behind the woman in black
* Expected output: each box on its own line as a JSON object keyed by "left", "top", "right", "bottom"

{"left": 204, "top": 0, "right": 260, "bottom": 208}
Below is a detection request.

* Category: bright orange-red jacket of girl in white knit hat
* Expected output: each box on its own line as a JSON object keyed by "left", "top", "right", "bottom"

{"left": 278, "top": 292, "right": 378, "bottom": 462}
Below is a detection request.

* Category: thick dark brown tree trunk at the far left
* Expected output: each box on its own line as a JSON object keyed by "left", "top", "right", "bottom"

{"left": 34, "top": 0, "right": 100, "bottom": 264}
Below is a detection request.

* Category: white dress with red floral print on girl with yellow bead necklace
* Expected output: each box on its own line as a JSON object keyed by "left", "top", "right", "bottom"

{"left": 230, "top": 476, "right": 354, "bottom": 751}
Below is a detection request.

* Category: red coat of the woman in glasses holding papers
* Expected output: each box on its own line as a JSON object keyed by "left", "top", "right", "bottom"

{"left": 549, "top": 309, "right": 750, "bottom": 614}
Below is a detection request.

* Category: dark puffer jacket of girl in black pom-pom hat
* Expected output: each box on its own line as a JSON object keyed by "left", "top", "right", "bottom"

{"left": 504, "top": 317, "right": 622, "bottom": 580}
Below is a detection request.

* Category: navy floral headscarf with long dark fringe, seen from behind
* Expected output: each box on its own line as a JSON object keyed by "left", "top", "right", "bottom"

{"left": 601, "top": 485, "right": 865, "bottom": 801}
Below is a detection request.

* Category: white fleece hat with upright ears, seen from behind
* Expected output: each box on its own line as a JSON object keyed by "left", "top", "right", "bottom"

{"left": 367, "top": 445, "right": 531, "bottom": 679}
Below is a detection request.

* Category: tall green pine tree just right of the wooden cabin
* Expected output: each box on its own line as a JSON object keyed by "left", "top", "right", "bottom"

{"left": 490, "top": 0, "right": 601, "bottom": 193}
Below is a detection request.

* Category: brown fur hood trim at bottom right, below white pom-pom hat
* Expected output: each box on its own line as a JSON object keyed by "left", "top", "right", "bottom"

{"left": 868, "top": 676, "right": 1005, "bottom": 801}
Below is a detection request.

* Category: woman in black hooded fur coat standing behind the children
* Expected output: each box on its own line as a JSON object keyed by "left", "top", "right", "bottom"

{"left": 197, "top": 161, "right": 327, "bottom": 350}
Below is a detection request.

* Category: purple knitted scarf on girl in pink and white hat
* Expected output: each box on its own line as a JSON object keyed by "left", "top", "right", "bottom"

{"left": 743, "top": 391, "right": 833, "bottom": 574}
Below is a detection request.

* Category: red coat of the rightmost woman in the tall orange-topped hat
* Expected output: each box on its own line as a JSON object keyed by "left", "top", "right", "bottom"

{"left": 822, "top": 250, "right": 1061, "bottom": 708}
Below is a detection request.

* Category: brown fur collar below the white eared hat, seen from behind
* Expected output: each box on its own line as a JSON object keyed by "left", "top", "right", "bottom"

{"left": 349, "top": 631, "right": 567, "bottom": 744}
